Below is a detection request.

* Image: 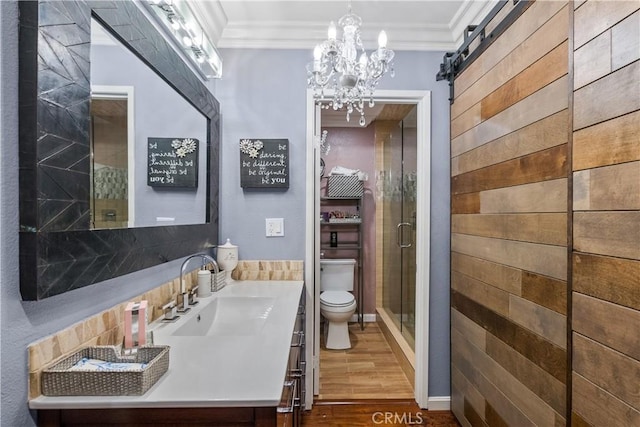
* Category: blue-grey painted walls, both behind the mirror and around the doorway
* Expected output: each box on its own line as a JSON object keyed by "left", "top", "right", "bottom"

{"left": 0, "top": 1, "right": 450, "bottom": 426}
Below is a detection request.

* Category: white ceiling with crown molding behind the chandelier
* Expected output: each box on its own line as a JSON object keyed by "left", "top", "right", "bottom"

{"left": 188, "top": 0, "right": 497, "bottom": 51}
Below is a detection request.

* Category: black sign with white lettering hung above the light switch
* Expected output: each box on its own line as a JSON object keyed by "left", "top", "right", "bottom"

{"left": 240, "top": 139, "right": 289, "bottom": 188}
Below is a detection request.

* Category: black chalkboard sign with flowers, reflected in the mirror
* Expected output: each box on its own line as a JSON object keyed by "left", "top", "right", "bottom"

{"left": 147, "top": 138, "right": 199, "bottom": 188}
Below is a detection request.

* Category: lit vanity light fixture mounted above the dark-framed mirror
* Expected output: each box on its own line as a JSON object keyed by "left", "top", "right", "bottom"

{"left": 143, "top": 0, "right": 222, "bottom": 79}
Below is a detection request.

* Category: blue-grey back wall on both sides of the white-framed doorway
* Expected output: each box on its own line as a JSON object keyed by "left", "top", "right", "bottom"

{"left": 216, "top": 49, "right": 450, "bottom": 396}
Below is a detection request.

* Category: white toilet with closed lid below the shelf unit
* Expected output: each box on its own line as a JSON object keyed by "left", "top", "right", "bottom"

{"left": 320, "top": 259, "right": 356, "bottom": 350}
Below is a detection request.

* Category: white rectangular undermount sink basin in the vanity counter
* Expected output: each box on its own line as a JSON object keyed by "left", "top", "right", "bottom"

{"left": 171, "top": 296, "right": 275, "bottom": 337}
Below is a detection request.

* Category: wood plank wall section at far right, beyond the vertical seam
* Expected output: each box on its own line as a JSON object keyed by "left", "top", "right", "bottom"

{"left": 571, "top": 0, "right": 640, "bottom": 426}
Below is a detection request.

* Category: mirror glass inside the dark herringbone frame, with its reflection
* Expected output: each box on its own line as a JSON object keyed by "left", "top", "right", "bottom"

{"left": 91, "top": 19, "right": 208, "bottom": 229}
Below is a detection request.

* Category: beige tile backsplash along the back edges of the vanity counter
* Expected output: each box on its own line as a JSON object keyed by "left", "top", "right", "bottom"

{"left": 27, "top": 261, "right": 304, "bottom": 399}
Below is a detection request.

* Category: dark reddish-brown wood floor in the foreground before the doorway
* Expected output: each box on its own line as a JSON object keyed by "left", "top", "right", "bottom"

{"left": 302, "top": 399, "right": 460, "bottom": 427}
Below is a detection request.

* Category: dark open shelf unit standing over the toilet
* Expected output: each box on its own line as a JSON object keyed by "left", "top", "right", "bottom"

{"left": 319, "top": 197, "right": 364, "bottom": 329}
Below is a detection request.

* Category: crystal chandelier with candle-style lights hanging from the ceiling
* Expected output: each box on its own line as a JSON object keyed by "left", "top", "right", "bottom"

{"left": 307, "top": 3, "right": 394, "bottom": 126}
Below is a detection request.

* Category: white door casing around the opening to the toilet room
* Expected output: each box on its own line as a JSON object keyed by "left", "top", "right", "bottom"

{"left": 305, "top": 89, "right": 435, "bottom": 409}
